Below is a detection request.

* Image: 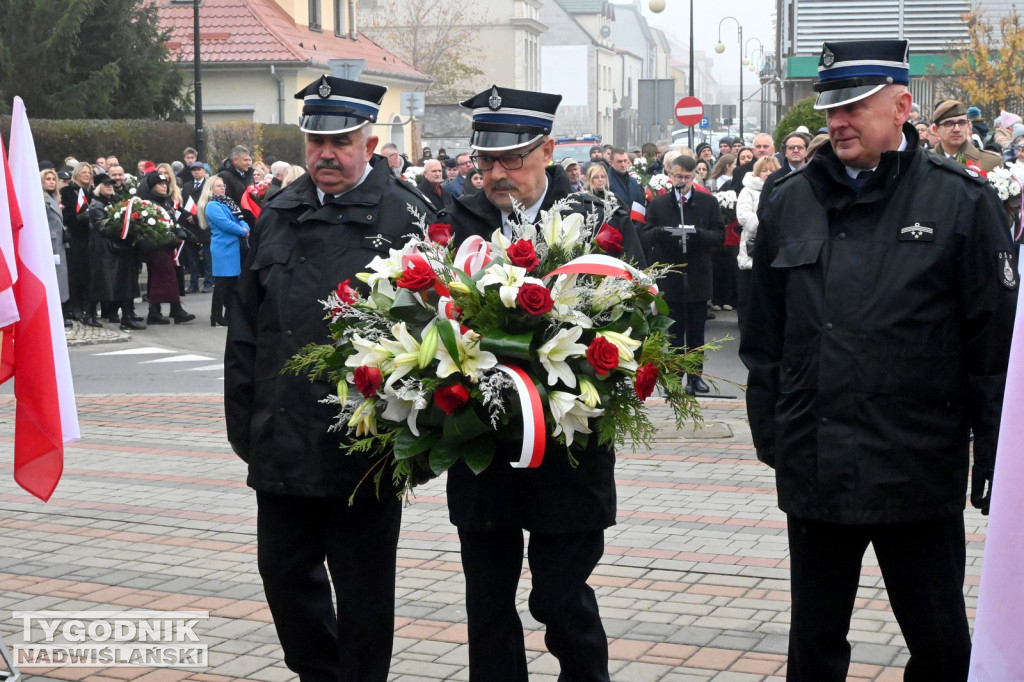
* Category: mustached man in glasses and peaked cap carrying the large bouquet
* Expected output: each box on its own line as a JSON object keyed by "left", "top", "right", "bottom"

{"left": 438, "top": 86, "right": 643, "bottom": 682}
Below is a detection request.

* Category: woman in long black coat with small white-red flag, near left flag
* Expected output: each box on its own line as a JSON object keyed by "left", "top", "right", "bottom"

{"left": 60, "top": 163, "right": 95, "bottom": 327}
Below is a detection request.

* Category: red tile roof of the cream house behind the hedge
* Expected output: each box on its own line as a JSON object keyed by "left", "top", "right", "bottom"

{"left": 157, "top": 0, "right": 429, "bottom": 82}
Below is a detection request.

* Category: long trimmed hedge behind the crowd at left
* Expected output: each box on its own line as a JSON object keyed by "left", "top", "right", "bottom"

{"left": 0, "top": 116, "right": 305, "bottom": 168}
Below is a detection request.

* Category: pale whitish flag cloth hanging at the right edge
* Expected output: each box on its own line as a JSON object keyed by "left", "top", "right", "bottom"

{"left": 968, "top": 296, "right": 1024, "bottom": 682}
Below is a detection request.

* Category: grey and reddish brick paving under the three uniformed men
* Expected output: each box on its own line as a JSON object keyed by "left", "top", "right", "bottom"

{"left": 0, "top": 395, "right": 985, "bottom": 682}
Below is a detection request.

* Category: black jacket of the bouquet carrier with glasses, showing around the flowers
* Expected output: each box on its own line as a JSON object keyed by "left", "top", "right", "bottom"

{"left": 438, "top": 166, "right": 644, "bottom": 532}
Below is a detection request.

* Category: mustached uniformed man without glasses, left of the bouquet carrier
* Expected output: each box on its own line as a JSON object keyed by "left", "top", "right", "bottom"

{"left": 224, "top": 76, "right": 434, "bottom": 682}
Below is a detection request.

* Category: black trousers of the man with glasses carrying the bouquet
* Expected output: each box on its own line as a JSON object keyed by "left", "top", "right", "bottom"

{"left": 459, "top": 528, "right": 609, "bottom": 682}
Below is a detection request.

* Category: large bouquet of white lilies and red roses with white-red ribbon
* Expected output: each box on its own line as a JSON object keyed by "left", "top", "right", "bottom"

{"left": 285, "top": 202, "right": 705, "bottom": 493}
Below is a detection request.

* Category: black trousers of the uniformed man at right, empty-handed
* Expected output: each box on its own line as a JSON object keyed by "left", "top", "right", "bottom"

{"left": 786, "top": 514, "right": 971, "bottom": 682}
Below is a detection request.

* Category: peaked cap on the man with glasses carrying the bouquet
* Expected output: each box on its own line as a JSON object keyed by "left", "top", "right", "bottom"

{"left": 462, "top": 85, "right": 562, "bottom": 152}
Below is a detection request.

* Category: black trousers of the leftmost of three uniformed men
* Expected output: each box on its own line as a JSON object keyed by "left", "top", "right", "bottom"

{"left": 256, "top": 492, "right": 401, "bottom": 682}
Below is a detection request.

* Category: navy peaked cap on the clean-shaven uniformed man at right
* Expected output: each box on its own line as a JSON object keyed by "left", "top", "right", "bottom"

{"left": 814, "top": 40, "right": 910, "bottom": 110}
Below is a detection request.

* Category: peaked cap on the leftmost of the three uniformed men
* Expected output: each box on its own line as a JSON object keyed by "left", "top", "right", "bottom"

{"left": 295, "top": 75, "right": 387, "bottom": 135}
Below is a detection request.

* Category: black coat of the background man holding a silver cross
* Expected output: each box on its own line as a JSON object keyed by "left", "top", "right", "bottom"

{"left": 640, "top": 189, "right": 725, "bottom": 303}
